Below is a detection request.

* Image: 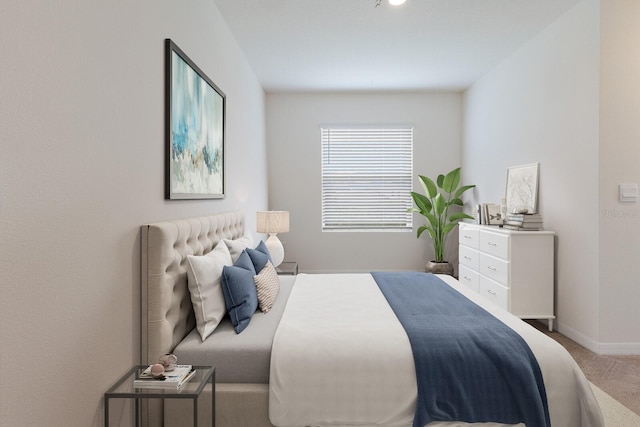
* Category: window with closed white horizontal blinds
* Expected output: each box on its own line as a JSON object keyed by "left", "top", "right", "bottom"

{"left": 321, "top": 127, "right": 413, "bottom": 231}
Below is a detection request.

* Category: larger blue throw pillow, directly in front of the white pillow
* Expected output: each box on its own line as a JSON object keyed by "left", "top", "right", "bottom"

{"left": 222, "top": 251, "right": 258, "bottom": 334}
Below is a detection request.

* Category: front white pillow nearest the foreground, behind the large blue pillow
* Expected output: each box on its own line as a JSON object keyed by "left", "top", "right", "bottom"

{"left": 187, "top": 242, "right": 233, "bottom": 341}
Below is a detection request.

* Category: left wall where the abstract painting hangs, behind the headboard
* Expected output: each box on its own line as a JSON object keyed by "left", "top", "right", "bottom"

{"left": 0, "top": 0, "right": 267, "bottom": 427}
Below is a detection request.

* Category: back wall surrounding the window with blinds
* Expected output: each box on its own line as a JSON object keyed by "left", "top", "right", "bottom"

{"left": 267, "top": 93, "right": 462, "bottom": 272}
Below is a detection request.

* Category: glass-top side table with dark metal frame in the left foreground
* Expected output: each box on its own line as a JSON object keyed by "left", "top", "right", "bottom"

{"left": 104, "top": 365, "right": 216, "bottom": 427}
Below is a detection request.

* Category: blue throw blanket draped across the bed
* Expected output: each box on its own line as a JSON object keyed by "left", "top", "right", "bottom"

{"left": 371, "top": 272, "right": 551, "bottom": 427}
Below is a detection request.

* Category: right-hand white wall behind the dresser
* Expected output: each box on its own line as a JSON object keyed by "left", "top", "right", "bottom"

{"left": 462, "top": 0, "right": 604, "bottom": 351}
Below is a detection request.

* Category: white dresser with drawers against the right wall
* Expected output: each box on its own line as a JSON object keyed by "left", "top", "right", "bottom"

{"left": 458, "top": 223, "right": 555, "bottom": 331}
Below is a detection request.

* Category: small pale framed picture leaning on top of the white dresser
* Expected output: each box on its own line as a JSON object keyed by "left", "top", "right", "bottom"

{"left": 505, "top": 163, "right": 540, "bottom": 214}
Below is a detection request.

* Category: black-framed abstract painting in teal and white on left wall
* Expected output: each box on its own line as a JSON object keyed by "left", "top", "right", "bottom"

{"left": 165, "top": 39, "right": 226, "bottom": 199}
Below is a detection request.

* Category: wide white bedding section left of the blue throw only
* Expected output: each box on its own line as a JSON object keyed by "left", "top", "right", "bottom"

{"left": 269, "top": 274, "right": 417, "bottom": 427}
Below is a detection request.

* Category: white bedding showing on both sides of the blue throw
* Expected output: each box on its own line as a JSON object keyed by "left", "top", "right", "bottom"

{"left": 269, "top": 274, "right": 604, "bottom": 427}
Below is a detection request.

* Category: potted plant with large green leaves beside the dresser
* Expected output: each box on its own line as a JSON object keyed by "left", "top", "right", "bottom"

{"left": 409, "top": 168, "right": 475, "bottom": 275}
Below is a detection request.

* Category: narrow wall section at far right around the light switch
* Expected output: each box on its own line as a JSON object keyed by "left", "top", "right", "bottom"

{"left": 599, "top": 0, "right": 640, "bottom": 354}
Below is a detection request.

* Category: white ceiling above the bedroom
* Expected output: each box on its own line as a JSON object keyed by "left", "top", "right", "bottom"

{"left": 215, "top": 0, "right": 579, "bottom": 92}
